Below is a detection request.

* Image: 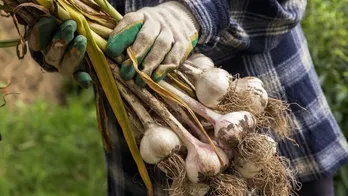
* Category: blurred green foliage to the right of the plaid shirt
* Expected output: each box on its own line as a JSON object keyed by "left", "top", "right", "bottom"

{"left": 302, "top": 0, "right": 348, "bottom": 196}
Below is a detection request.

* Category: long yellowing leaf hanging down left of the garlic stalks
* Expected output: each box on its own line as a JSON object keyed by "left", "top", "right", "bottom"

{"left": 58, "top": 0, "right": 153, "bottom": 195}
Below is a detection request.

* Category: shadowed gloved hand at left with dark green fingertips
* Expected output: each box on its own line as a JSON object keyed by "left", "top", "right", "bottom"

{"left": 28, "top": 17, "right": 92, "bottom": 88}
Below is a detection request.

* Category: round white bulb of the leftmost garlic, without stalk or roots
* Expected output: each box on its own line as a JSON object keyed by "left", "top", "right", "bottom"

{"left": 140, "top": 126, "right": 182, "bottom": 164}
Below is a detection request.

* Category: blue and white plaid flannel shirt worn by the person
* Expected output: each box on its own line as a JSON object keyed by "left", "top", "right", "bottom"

{"left": 89, "top": 0, "right": 348, "bottom": 196}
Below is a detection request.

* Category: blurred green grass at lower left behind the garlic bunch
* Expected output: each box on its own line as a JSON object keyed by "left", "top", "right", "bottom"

{"left": 0, "top": 89, "right": 106, "bottom": 196}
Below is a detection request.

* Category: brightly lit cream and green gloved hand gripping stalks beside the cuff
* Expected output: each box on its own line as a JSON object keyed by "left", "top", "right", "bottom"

{"left": 107, "top": 1, "right": 200, "bottom": 86}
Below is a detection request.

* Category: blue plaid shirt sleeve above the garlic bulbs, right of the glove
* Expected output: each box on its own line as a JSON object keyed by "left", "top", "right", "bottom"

{"left": 182, "top": 0, "right": 307, "bottom": 53}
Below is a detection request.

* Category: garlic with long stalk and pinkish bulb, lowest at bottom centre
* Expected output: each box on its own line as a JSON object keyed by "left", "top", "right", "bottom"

{"left": 113, "top": 66, "right": 229, "bottom": 183}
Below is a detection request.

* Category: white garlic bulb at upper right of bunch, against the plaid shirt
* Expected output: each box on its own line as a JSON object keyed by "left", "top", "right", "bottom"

{"left": 232, "top": 77, "right": 268, "bottom": 114}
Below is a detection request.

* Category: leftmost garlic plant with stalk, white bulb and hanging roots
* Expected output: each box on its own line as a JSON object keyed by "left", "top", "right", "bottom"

{"left": 118, "top": 77, "right": 210, "bottom": 196}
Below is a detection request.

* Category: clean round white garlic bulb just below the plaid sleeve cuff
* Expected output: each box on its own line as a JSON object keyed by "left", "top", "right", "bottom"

{"left": 195, "top": 68, "right": 232, "bottom": 108}
